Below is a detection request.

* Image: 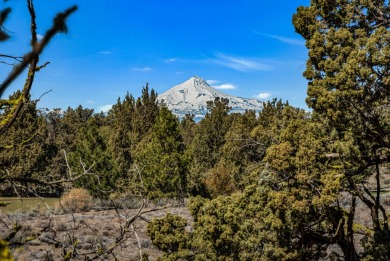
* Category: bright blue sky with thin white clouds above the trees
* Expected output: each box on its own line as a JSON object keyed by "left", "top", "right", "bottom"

{"left": 0, "top": 0, "right": 309, "bottom": 110}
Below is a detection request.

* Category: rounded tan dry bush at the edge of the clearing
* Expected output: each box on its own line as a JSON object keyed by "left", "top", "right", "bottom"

{"left": 59, "top": 188, "right": 93, "bottom": 213}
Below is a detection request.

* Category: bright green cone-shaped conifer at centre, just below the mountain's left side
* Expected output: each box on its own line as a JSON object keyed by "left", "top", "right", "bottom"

{"left": 136, "top": 107, "right": 187, "bottom": 199}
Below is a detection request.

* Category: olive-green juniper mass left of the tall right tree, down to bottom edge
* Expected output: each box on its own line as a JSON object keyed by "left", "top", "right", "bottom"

{"left": 150, "top": 104, "right": 344, "bottom": 260}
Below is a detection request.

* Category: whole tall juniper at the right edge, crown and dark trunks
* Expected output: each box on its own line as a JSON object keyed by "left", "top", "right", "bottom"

{"left": 293, "top": 1, "right": 390, "bottom": 260}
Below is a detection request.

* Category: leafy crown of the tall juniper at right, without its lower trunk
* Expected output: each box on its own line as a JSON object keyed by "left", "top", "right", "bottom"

{"left": 293, "top": 1, "right": 390, "bottom": 173}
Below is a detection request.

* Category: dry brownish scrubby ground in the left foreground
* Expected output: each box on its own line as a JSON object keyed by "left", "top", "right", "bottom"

{"left": 0, "top": 204, "right": 190, "bottom": 261}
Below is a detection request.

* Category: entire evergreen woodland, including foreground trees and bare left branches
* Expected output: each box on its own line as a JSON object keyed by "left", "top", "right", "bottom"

{"left": 0, "top": 0, "right": 390, "bottom": 260}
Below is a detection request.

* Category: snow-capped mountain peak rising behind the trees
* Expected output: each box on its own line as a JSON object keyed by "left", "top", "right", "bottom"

{"left": 158, "top": 76, "right": 263, "bottom": 119}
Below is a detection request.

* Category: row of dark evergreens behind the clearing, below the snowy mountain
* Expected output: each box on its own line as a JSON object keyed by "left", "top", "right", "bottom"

{"left": 0, "top": 86, "right": 266, "bottom": 200}
